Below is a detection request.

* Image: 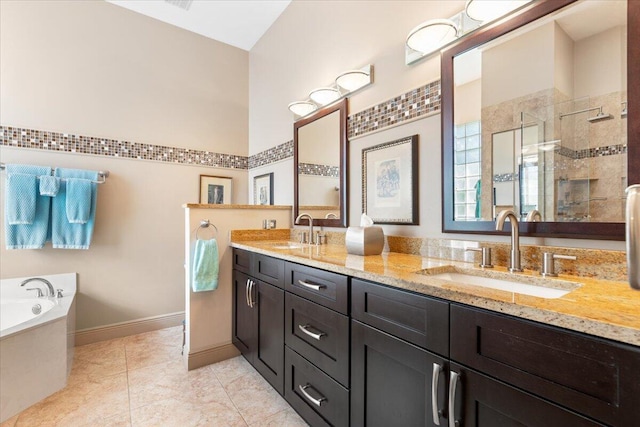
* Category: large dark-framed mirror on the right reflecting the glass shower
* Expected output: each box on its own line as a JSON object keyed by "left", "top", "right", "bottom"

{"left": 442, "top": 0, "right": 640, "bottom": 240}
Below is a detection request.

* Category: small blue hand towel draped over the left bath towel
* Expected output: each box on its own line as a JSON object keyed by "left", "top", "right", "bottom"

{"left": 6, "top": 173, "right": 38, "bottom": 225}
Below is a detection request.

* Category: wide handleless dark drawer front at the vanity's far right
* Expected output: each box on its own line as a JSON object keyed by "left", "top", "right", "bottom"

{"left": 451, "top": 305, "right": 640, "bottom": 426}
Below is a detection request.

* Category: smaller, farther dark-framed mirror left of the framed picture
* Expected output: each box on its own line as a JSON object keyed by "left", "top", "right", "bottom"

{"left": 293, "top": 98, "right": 349, "bottom": 227}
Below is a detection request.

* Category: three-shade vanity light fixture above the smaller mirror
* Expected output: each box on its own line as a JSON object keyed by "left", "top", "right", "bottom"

{"left": 289, "top": 64, "right": 373, "bottom": 120}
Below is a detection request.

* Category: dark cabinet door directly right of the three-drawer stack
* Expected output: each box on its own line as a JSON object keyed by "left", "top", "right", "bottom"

{"left": 351, "top": 320, "right": 448, "bottom": 427}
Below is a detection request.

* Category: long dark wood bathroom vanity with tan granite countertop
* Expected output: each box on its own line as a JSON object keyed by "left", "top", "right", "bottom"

{"left": 233, "top": 242, "right": 640, "bottom": 427}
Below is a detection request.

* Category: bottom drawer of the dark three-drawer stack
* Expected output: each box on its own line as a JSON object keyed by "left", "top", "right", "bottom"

{"left": 284, "top": 347, "right": 349, "bottom": 427}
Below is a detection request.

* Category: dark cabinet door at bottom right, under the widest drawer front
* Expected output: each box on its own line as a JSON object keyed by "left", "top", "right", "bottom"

{"left": 450, "top": 364, "right": 604, "bottom": 427}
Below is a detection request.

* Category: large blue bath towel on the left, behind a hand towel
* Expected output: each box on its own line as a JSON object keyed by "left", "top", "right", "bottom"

{"left": 4, "top": 165, "right": 51, "bottom": 249}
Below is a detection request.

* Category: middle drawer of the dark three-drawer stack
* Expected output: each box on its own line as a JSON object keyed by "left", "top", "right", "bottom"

{"left": 285, "top": 292, "right": 349, "bottom": 387}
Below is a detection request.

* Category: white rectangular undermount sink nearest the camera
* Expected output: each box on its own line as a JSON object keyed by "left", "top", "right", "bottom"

{"left": 420, "top": 267, "right": 582, "bottom": 299}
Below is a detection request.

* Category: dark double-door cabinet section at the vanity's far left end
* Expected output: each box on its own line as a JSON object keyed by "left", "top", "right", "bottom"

{"left": 232, "top": 249, "right": 284, "bottom": 394}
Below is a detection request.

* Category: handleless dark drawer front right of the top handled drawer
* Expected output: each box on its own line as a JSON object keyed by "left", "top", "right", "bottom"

{"left": 351, "top": 279, "right": 449, "bottom": 356}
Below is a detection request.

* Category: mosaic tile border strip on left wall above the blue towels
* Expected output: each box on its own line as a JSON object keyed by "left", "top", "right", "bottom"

{"left": 0, "top": 126, "right": 249, "bottom": 169}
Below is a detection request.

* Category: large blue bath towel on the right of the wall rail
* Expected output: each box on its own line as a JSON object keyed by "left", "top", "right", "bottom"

{"left": 51, "top": 168, "right": 98, "bottom": 249}
